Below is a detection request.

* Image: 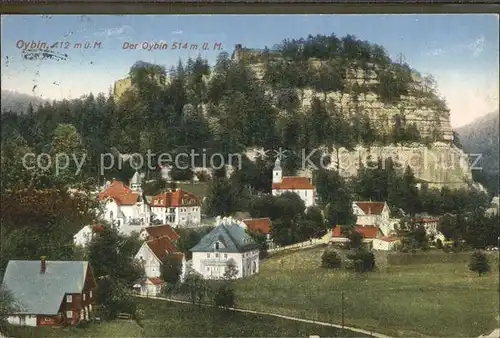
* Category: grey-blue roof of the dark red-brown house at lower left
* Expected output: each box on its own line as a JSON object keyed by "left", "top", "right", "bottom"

{"left": 2, "top": 260, "right": 89, "bottom": 315}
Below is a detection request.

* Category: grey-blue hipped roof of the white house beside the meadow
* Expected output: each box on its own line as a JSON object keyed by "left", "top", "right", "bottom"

{"left": 191, "top": 223, "right": 259, "bottom": 253}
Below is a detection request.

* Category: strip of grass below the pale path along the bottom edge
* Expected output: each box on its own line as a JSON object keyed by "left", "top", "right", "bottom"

{"left": 5, "top": 299, "right": 361, "bottom": 338}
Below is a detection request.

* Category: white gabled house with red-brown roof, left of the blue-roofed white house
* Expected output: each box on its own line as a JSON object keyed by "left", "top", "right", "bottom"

{"left": 134, "top": 230, "right": 186, "bottom": 295}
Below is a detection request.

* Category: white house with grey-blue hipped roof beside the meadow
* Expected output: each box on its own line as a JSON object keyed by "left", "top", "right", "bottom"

{"left": 191, "top": 217, "right": 259, "bottom": 279}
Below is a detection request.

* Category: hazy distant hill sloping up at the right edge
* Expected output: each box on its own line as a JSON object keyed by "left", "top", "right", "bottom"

{"left": 457, "top": 111, "right": 499, "bottom": 193}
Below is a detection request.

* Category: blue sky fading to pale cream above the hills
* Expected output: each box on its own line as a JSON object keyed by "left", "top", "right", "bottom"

{"left": 1, "top": 14, "right": 499, "bottom": 128}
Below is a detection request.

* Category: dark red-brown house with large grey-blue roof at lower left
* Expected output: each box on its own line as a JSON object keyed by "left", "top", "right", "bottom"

{"left": 2, "top": 257, "right": 96, "bottom": 326}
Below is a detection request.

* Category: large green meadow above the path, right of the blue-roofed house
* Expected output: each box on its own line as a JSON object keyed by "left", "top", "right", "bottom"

{"left": 237, "top": 248, "right": 499, "bottom": 337}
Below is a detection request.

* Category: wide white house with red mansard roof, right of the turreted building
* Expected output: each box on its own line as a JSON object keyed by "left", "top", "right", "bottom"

{"left": 151, "top": 189, "right": 201, "bottom": 227}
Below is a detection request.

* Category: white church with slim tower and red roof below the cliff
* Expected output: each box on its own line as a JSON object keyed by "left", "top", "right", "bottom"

{"left": 272, "top": 157, "right": 316, "bottom": 208}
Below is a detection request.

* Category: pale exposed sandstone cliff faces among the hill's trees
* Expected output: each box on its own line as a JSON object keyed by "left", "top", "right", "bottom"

{"left": 240, "top": 45, "right": 483, "bottom": 190}
